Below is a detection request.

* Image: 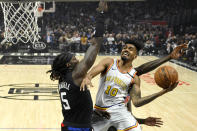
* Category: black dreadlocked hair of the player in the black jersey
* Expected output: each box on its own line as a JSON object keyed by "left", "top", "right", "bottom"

{"left": 47, "top": 53, "right": 73, "bottom": 80}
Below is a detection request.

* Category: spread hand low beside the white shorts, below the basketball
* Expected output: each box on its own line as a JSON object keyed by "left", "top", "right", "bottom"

{"left": 144, "top": 117, "right": 163, "bottom": 127}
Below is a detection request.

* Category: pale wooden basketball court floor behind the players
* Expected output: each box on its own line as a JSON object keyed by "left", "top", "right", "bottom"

{"left": 0, "top": 56, "right": 197, "bottom": 131}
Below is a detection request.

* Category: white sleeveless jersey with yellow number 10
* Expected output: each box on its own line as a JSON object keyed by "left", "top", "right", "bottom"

{"left": 94, "top": 59, "right": 137, "bottom": 110}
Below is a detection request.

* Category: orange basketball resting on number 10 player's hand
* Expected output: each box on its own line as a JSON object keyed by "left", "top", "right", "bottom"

{"left": 154, "top": 66, "right": 178, "bottom": 89}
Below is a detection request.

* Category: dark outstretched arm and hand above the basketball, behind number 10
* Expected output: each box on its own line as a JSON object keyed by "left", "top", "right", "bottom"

{"left": 135, "top": 44, "right": 187, "bottom": 76}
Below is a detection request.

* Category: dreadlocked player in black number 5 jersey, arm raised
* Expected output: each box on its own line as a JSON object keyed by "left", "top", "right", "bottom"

{"left": 48, "top": 1, "right": 107, "bottom": 131}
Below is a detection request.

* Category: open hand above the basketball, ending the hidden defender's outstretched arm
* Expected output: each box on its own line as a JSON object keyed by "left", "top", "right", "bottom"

{"left": 170, "top": 44, "right": 188, "bottom": 59}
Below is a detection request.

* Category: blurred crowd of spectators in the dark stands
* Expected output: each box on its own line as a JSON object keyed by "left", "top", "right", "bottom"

{"left": 0, "top": 0, "right": 197, "bottom": 65}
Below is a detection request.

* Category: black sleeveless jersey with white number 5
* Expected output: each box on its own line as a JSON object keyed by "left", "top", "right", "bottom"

{"left": 58, "top": 72, "right": 93, "bottom": 128}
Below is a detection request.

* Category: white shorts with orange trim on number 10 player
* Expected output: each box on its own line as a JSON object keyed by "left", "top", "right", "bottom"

{"left": 92, "top": 104, "right": 141, "bottom": 131}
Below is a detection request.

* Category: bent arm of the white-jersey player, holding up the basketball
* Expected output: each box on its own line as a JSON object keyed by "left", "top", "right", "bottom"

{"left": 130, "top": 76, "right": 178, "bottom": 107}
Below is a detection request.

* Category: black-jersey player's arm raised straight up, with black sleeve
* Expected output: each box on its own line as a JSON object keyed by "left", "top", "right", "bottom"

{"left": 72, "top": 2, "right": 107, "bottom": 86}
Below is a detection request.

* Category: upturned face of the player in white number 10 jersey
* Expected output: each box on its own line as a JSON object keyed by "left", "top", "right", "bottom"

{"left": 121, "top": 44, "right": 137, "bottom": 61}
